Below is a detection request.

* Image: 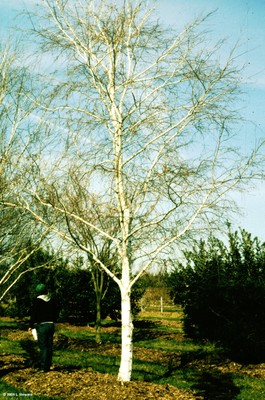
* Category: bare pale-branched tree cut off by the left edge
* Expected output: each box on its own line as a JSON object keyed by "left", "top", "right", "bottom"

{"left": 0, "top": 40, "right": 52, "bottom": 300}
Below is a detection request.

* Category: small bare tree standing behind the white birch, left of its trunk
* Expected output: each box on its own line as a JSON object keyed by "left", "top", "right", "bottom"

{"left": 57, "top": 170, "right": 120, "bottom": 343}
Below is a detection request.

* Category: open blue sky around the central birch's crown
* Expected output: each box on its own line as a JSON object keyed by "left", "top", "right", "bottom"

{"left": 0, "top": 0, "right": 265, "bottom": 241}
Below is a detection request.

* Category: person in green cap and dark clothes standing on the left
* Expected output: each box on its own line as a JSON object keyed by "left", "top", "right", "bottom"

{"left": 29, "top": 283, "right": 57, "bottom": 372}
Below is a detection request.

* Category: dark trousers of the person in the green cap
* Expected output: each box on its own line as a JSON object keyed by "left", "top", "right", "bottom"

{"left": 37, "top": 322, "right": 54, "bottom": 372}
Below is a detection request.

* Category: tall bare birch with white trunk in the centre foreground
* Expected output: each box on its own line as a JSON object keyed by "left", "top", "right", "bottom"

{"left": 5, "top": 0, "right": 258, "bottom": 382}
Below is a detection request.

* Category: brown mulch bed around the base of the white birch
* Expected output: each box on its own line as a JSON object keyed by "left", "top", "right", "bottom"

{"left": 4, "top": 369, "right": 198, "bottom": 400}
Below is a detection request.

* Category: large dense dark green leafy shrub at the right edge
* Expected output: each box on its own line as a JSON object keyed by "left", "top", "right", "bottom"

{"left": 168, "top": 230, "right": 265, "bottom": 362}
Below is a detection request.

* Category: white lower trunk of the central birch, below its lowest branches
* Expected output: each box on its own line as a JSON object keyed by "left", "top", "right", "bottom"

{"left": 118, "top": 288, "right": 133, "bottom": 382}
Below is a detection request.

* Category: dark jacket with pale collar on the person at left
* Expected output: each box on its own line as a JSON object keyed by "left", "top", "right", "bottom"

{"left": 30, "top": 295, "right": 57, "bottom": 328}
